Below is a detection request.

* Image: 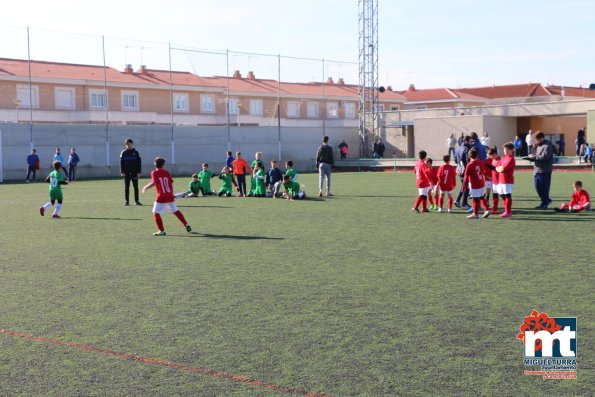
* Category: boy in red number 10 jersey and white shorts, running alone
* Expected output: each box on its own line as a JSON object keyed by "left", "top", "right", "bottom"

{"left": 143, "top": 157, "right": 192, "bottom": 236}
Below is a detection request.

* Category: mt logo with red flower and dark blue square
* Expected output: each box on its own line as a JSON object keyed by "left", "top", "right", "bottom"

{"left": 517, "top": 310, "right": 576, "bottom": 358}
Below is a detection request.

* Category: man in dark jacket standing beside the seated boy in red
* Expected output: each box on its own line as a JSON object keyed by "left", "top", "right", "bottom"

{"left": 528, "top": 131, "right": 554, "bottom": 210}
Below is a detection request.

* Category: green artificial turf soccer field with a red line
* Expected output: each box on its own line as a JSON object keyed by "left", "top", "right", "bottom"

{"left": 0, "top": 173, "right": 595, "bottom": 397}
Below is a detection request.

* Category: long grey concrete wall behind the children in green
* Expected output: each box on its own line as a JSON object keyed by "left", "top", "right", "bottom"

{"left": 0, "top": 123, "right": 359, "bottom": 180}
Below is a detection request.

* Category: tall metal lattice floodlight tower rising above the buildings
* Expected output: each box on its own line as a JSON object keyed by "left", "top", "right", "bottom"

{"left": 358, "top": 0, "right": 378, "bottom": 157}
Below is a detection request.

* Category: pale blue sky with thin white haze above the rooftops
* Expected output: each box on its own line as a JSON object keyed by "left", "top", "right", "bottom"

{"left": 0, "top": 0, "right": 595, "bottom": 89}
